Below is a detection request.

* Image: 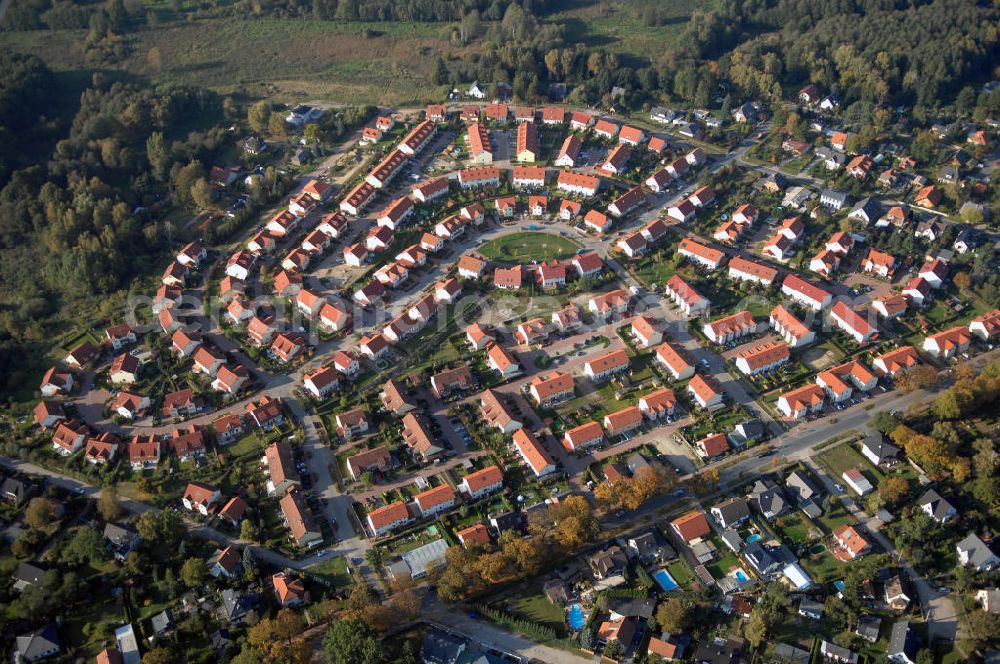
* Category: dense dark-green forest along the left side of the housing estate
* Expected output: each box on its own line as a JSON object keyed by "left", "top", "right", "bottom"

{"left": 0, "top": 53, "right": 240, "bottom": 396}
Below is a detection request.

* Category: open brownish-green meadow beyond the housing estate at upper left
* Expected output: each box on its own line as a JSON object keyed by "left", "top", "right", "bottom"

{"left": 0, "top": 17, "right": 458, "bottom": 104}
